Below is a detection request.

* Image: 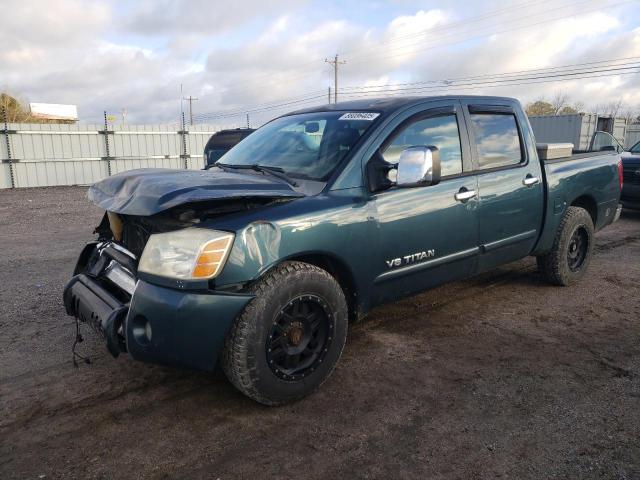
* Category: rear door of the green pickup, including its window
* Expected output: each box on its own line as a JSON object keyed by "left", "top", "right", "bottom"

{"left": 463, "top": 99, "right": 544, "bottom": 271}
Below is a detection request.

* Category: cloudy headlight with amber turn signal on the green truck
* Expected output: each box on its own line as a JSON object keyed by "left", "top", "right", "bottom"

{"left": 138, "top": 228, "right": 234, "bottom": 280}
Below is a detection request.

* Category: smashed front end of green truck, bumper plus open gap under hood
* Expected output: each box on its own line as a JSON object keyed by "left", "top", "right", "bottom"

{"left": 64, "top": 198, "right": 283, "bottom": 370}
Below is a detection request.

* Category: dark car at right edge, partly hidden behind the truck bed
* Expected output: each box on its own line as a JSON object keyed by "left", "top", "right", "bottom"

{"left": 591, "top": 132, "right": 640, "bottom": 209}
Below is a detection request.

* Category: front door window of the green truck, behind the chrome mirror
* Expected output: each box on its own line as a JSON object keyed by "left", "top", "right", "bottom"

{"left": 382, "top": 115, "right": 462, "bottom": 177}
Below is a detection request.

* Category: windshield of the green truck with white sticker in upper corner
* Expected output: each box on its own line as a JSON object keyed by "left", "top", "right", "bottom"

{"left": 217, "top": 112, "right": 379, "bottom": 180}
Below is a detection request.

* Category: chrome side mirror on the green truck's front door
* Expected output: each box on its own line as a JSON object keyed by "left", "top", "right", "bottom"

{"left": 396, "top": 146, "right": 440, "bottom": 187}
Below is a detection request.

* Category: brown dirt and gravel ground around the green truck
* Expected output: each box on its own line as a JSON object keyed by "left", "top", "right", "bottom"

{"left": 0, "top": 187, "right": 640, "bottom": 479}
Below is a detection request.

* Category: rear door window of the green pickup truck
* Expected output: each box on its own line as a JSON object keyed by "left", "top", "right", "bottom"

{"left": 471, "top": 113, "right": 523, "bottom": 168}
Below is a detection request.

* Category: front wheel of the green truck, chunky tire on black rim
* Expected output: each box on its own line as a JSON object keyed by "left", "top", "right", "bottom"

{"left": 220, "top": 262, "right": 348, "bottom": 406}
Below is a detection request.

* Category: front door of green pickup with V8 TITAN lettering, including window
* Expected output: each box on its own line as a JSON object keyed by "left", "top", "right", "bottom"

{"left": 372, "top": 103, "right": 478, "bottom": 303}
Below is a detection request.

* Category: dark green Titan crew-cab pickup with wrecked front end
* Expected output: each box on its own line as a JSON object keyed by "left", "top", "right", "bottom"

{"left": 64, "top": 96, "right": 622, "bottom": 405}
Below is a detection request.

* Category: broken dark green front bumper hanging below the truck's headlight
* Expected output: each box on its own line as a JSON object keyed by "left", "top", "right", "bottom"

{"left": 64, "top": 244, "right": 253, "bottom": 370}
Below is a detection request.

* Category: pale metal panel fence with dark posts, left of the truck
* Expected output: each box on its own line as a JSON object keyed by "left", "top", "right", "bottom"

{"left": 0, "top": 111, "right": 220, "bottom": 188}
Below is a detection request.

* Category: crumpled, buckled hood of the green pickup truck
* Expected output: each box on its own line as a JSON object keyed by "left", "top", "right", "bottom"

{"left": 88, "top": 168, "right": 304, "bottom": 216}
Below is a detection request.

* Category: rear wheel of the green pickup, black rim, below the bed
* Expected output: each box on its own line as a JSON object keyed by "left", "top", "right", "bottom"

{"left": 538, "top": 207, "right": 595, "bottom": 286}
